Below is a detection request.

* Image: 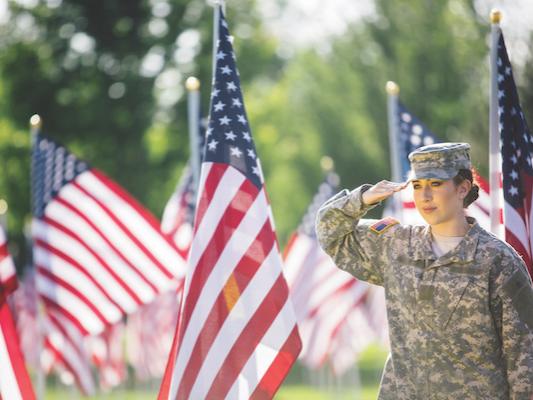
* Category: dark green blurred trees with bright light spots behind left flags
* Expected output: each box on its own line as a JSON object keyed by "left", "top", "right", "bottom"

{"left": 0, "top": 0, "right": 282, "bottom": 268}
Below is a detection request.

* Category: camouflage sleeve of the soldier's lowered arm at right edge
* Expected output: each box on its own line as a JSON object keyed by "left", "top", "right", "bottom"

{"left": 490, "top": 251, "right": 533, "bottom": 400}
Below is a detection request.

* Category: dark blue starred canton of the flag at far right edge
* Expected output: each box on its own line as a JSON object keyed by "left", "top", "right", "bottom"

{"left": 497, "top": 34, "right": 533, "bottom": 208}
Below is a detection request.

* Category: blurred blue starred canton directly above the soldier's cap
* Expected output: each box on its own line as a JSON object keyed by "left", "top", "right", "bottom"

{"left": 397, "top": 102, "right": 439, "bottom": 179}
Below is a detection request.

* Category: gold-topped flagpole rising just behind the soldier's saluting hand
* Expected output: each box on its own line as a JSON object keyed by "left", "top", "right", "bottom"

{"left": 385, "top": 81, "right": 405, "bottom": 219}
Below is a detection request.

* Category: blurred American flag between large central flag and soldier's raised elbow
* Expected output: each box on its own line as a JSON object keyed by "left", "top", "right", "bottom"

{"left": 284, "top": 172, "right": 372, "bottom": 374}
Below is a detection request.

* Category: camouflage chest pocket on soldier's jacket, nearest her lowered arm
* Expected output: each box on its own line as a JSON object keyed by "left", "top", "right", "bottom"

{"left": 430, "top": 265, "right": 487, "bottom": 330}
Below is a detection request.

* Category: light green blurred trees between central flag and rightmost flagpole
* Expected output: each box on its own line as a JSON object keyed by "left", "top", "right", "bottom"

{"left": 245, "top": 0, "right": 489, "bottom": 242}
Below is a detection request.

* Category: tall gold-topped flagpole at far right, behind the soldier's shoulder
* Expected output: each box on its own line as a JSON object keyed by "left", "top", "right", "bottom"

{"left": 489, "top": 9, "right": 503, "bottom": 239}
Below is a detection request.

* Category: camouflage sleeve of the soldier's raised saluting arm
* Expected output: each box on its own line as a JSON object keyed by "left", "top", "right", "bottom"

{"left": 316, "top": 185, "right": 396, "bottom": 286}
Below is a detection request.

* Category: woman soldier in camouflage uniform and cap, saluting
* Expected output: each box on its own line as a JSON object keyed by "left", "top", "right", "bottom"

{"left": 316, "top": 143, "right": 533, "bottom": 400}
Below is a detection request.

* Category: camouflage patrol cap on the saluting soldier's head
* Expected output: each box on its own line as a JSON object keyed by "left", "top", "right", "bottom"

{"left": 409, "top": 143, "right": 472, "bottom": 180}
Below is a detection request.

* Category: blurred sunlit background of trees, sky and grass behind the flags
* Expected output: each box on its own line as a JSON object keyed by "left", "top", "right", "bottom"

{"left": 0, "top": 0, "right": 533, "bottom": 399}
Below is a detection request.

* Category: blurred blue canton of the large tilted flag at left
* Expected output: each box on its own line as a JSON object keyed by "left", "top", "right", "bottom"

{"left": 31, "top": 134, "right": 90, "bottom": 218}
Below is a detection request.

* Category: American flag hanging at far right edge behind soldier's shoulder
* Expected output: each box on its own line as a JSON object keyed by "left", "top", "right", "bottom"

{"left": 495, "top": 34, "right": 533, "bottom": 276}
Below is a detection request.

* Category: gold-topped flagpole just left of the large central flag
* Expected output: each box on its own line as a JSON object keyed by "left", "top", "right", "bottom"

{"left": 185, "top": 76, "right": 200, "bottom": 196}
